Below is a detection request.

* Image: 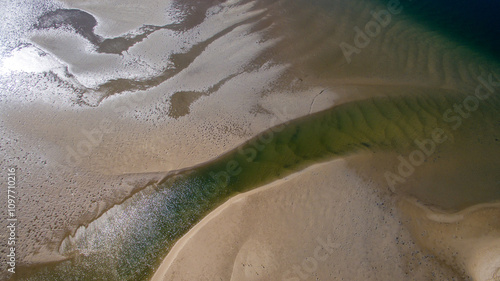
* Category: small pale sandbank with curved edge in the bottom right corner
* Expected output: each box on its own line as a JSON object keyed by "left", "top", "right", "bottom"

{"left": 399, "top": 199, "right": 500, "bottom": 281}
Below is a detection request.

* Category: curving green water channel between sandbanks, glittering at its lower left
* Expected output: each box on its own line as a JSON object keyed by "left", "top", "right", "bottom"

{"left": 16, "top": 88, "right": 500, "bottom": 280}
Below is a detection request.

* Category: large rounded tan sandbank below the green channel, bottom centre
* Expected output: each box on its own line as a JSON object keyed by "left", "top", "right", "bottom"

{"left": 152, "top": 159, "right": 466, "bottom": 281}
